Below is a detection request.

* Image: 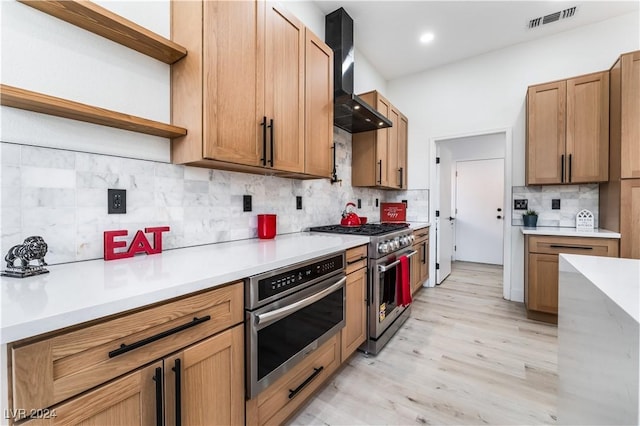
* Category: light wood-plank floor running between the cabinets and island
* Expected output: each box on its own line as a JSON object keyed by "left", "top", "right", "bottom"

{"left": 290, "top": 262, "right": 557, "bottom": 425}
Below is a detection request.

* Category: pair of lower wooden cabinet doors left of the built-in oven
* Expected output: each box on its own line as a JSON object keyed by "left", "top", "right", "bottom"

{"left": 25, "top": 325, "right": 244, "bottom": 426}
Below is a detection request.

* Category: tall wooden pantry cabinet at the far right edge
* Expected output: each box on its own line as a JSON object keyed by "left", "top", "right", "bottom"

{"left": 600, "top": 51, "right": 640, "bottom": 259}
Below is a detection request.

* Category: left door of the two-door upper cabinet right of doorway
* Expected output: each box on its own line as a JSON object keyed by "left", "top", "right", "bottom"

{"left": 526, "top": 81, "right": 567, "bottom": 185}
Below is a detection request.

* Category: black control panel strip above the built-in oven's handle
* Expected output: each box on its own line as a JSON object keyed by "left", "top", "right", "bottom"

{"left": 258, "top": 254, "right": 344, "bottom": 300}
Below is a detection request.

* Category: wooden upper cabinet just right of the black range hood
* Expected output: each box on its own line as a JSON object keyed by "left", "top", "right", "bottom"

{"left": 351, "top": 91, "right": 408, "bottom": 189}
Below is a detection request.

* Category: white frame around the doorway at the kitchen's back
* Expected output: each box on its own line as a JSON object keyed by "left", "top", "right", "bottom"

{"left": 429, "top": 127, "right": 513, "bottom": 300}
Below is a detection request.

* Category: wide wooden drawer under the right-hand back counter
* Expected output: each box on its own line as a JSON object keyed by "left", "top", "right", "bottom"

{"left": 528, "top": 235, "right": 618, "bottom": 257}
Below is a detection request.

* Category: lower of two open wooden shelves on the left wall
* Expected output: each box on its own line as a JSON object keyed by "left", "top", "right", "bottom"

{"left": 0, "top": 84, "right": 187, "bottom": 138}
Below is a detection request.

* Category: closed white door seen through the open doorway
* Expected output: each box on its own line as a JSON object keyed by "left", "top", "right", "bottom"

{"left": 456, "top": 158, "right": 504, "bottom": 265}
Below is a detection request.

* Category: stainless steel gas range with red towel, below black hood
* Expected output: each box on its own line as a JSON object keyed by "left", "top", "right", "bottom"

{"left": 309, "top": 223, "right": 416, "bottom": 354}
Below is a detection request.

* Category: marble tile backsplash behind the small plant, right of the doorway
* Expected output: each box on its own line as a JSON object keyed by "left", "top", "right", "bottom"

{"left": 511, "top": 183, "right": 599, "bottom": 228}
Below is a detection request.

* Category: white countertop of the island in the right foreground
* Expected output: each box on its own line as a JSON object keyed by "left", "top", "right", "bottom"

{"left": 559, "top": 254, "right": 640, "bottom": 322}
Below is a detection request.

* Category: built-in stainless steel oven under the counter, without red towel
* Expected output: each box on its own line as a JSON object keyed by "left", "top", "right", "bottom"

{"left": 245, "top": 252, "right": 347, "bottom": 398}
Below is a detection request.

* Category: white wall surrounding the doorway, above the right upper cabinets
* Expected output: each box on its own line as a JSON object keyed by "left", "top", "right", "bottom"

{"left": 387, "top": 13, "right": 640, "bottom": 188}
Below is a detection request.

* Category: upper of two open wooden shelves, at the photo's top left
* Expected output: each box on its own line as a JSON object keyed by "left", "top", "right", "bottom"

{"left": 18, "top": 0, "right": 187, "bottom": 64}
